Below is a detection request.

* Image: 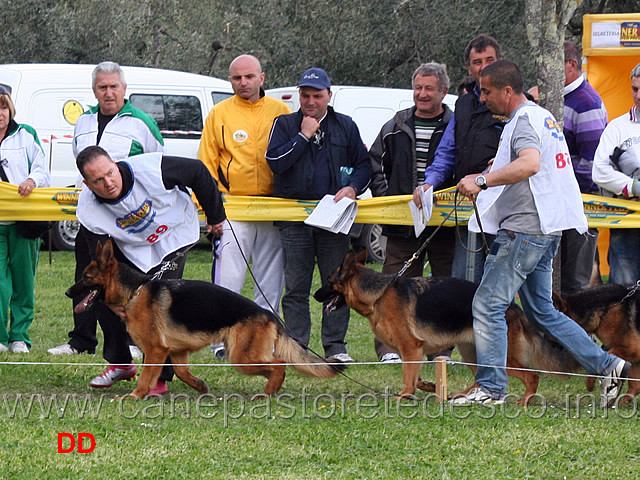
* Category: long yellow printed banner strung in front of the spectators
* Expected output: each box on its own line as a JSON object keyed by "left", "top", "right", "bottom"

{"left": 0, "top": 182, "right": 640, "bottom": 228}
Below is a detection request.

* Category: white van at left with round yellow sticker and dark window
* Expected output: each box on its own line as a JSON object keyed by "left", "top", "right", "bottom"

{"left": 0, "top": 64, "right": 233, "bottom": 250}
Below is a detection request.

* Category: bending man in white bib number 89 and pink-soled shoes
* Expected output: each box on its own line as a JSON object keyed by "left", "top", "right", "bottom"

{"left": 76, "top": 146, "right": 226, "bottom": 394}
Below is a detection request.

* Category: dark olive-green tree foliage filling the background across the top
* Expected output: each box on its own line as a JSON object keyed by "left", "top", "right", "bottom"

{"left": 0, "top": 0, "right": 640, "bottom": 90}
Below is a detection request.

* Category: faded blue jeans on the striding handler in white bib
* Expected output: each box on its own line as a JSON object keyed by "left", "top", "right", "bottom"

{"left": 473, "top": 230, "right": 617, "bottom": 395}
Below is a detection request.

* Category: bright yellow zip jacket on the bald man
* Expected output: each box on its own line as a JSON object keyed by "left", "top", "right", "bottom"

{"left": 198, "top": 95, "right": 291, "bottom": 195}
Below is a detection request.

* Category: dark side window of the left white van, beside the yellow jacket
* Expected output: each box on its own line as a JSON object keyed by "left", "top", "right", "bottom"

{"left": 129, "top": 93, "right": 202, "bottom": 138}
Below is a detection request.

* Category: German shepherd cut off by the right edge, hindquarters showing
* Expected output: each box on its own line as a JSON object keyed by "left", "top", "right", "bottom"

{"left": 553, "top": 283, "right": 640, "bottom": 403}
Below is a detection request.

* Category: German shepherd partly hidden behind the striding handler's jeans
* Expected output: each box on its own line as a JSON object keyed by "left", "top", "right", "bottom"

{"left": 314, "top": 250, "right": 579, "bottom": 405}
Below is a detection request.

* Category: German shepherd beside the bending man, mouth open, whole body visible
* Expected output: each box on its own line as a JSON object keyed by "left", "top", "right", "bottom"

{"left": 67, "top": 240, "right": 345, "bottom": 399}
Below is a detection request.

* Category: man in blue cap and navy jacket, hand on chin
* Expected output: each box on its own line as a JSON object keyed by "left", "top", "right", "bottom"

{"left": 266, "top": 68, "right": 371, "bottom": 362}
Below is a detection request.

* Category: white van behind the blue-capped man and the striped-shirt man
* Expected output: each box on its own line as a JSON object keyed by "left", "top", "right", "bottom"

{"left": 266, "top": 85, "right": 458, "bottom": 148}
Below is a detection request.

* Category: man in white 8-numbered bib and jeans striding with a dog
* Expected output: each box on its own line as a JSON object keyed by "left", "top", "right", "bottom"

{"left": 453, "top": 60, "right": 631, "bottom": 408}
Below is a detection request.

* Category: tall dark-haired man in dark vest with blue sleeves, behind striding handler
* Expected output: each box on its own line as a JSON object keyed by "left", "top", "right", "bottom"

{"left": 414, "top": 34, "right": 507, "bottom": 283}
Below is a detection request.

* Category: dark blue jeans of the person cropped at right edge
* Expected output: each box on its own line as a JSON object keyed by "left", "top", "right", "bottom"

{"left": 608, "top": 228, "right": 640, "bottom": 286}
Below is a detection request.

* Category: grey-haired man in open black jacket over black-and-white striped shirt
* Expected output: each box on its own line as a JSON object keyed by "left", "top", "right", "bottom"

{"left": 369, "top": 63, "right": 455, "bottom": 363}
